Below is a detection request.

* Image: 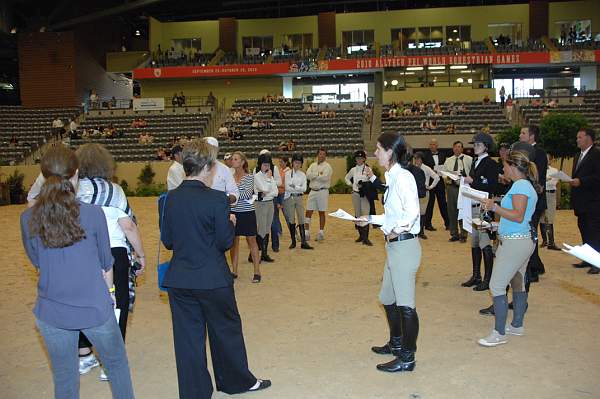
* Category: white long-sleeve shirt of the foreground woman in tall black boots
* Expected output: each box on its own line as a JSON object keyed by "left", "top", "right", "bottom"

{"left": 374, "top": 164, "right": 421, "bottom": 235}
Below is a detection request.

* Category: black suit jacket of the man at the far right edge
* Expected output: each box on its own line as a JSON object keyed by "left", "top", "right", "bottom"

{"left": 571, "top": 146, "right": 600, "bottom": 216}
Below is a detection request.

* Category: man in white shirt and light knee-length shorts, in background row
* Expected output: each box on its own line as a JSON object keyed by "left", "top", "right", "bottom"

{"left": 305, "top": 148, "right": 333, "bottom": 241}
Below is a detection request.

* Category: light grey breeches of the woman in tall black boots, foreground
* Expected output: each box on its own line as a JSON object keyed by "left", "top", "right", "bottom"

{"left": 379, "top": 238, "right": 421, "bottom": 309}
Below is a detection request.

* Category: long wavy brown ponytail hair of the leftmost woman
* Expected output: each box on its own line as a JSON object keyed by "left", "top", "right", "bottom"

{"left": 29, "top": 145, "right": 85, "bottom": 248}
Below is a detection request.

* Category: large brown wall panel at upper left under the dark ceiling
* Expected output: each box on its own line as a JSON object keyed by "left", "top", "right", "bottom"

{"left": 19, "top": 32, "right": 79, "bottom": 108}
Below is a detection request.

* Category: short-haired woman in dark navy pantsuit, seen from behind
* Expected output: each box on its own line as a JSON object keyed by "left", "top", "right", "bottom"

{"left": 161, "top": 140, "right": 271, "bottom": 399}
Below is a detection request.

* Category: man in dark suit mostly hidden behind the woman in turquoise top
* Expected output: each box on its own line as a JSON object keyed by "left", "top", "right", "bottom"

{"left": 519, "top": 125, "right": 548, "bottom": 287}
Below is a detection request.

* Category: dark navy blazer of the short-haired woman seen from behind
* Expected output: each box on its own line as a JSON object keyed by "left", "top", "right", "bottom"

{"left": 161, "top": 180, "right": 235, "bottom": 290}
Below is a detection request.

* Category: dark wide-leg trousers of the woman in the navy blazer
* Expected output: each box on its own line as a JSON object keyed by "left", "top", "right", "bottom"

{"left": 169, "top": 286, "right": 256, "bottom": 399}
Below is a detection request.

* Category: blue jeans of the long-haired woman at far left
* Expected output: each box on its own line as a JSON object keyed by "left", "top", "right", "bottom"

{"left": 36, "top": 316, "right": 134, "bottom": 399}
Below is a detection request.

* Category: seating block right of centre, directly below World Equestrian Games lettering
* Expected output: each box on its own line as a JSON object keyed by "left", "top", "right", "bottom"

{"left": 381, "top": 102, "right": 510, "bottom": 135}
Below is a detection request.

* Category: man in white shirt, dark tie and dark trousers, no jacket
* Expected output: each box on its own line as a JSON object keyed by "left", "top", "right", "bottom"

{"left": 444, "top": 141, "right": 473, "bottom": 242}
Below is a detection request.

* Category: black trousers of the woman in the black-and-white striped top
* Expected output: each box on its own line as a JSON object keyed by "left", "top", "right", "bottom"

{"left": 79, "top": 247, "right": 130, "bottom": 348}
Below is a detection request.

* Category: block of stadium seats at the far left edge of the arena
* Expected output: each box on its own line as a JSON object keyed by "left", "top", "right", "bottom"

{"left": 0, "top": 106, "right": 80, "bottom": 165}
